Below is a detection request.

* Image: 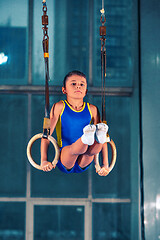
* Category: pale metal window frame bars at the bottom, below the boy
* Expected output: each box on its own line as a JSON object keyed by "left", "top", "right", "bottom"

{"left": 0, "top": 196, "right": 131, "bottom": 240}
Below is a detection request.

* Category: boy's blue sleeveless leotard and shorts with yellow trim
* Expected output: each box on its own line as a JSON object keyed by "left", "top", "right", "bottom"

{"left": 56, "top": 100, "right": 92, "bottom": 173}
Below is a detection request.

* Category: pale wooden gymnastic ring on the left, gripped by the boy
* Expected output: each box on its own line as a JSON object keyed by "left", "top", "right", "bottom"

{"left": 27, "top": 133, "right": 60, "bottom": 170}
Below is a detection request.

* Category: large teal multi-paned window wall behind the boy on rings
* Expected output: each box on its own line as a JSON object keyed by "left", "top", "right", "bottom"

{"left": 0, "top": 0, "right": 139, "bottom": 240}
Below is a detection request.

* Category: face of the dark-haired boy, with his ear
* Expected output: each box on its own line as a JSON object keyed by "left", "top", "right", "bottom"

{"left": 62, "top": 75, "right": 87, "bottom": 99}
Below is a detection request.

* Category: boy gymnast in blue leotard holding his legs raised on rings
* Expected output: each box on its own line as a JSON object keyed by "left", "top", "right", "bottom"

{"left": 41, "top": 71, "right": 109, "bottom": 176}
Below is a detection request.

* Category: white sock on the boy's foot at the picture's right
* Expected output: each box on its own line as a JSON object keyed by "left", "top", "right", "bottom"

{"left": 96, "top": 123, "right": 108, "bottom": 144}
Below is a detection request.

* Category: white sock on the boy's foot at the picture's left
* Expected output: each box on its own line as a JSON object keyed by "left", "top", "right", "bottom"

{"left": 81, "top": 124, "right": 96, "bottom": 145}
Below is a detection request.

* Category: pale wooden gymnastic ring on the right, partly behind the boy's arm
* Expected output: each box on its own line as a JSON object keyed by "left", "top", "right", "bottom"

{"left": 94, "top": 139, "right": 117, "bottom": 172}
